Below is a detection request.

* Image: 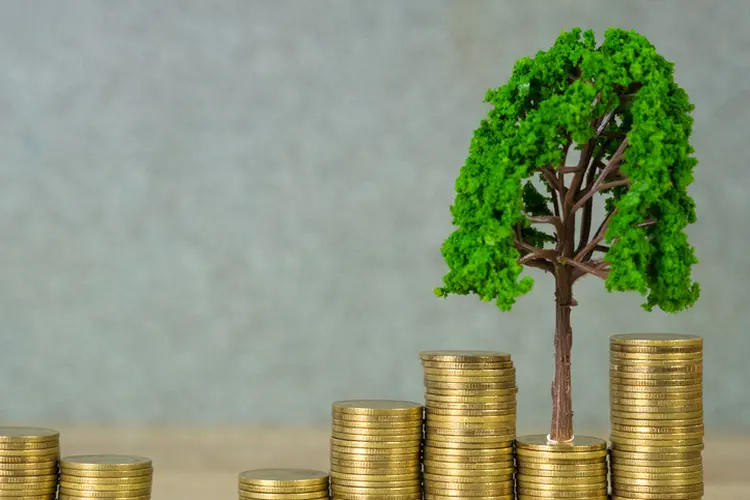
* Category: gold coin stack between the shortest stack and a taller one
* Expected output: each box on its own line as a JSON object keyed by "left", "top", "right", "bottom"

{"left": 330, "top": 399, "right": 423, "bottom": 500}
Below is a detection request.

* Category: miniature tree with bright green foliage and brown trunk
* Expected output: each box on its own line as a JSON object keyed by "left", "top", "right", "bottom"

{"left": 436, "top": 28, "right": 699, "bottom": 442}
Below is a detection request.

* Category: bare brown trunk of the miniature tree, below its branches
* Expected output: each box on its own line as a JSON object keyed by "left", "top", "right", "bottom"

{"left": 550, "top": 265, "right": 573, "bottom": 443}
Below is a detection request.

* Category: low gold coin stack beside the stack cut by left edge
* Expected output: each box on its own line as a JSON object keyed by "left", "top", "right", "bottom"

{"left": 59, "top": 455, "right": 154, "bottom": 500}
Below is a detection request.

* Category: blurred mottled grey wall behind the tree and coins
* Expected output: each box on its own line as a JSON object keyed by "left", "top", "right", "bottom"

{"left": 0, "top": 0, "right": 750, "bottom": 432}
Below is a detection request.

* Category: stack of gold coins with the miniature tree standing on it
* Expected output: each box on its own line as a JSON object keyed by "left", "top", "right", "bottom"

{"left": 516, "top": 435, "right": 607, "bottom": 500}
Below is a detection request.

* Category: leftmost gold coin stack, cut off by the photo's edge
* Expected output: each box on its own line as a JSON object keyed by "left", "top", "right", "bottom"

{"left": 0, "top": 427, "right": 60, "bottom": 499}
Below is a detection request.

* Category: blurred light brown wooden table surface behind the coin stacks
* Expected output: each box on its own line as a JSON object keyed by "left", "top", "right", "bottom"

{"left": 51, "top": 426, "right": 750, "bottom": 500}
